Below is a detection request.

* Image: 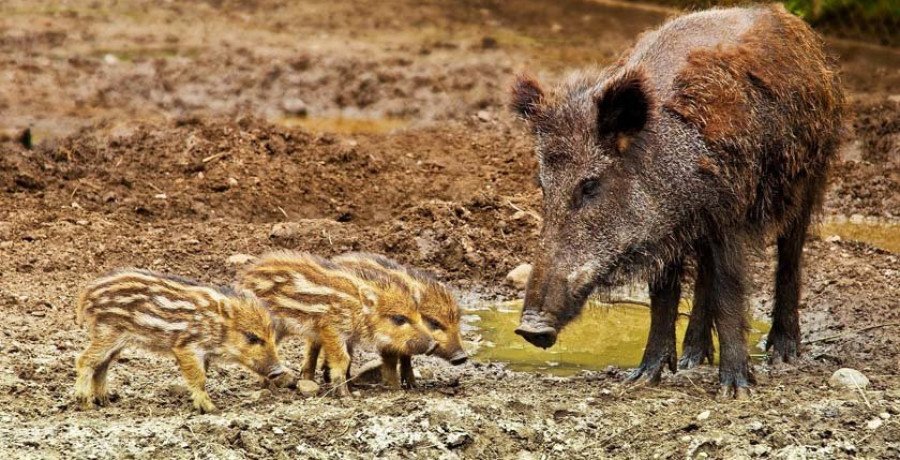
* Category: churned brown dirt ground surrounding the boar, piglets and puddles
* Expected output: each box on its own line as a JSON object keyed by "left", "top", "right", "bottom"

{"left": 0, "top": 0, "right": 900, "bottom": 459}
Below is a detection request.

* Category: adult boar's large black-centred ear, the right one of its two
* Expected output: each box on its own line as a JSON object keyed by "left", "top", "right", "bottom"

{"left": 597, "top": 70, "right": 654, "bottom": 136}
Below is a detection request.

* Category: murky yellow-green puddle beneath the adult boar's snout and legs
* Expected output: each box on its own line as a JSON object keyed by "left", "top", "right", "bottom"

{"left": 468, "top": 301, "right": 769, "bottom": 376}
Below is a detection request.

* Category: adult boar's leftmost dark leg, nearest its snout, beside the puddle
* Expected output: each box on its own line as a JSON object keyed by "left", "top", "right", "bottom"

{"left": 628, "top": 260, "right": 683, "bottom": 385}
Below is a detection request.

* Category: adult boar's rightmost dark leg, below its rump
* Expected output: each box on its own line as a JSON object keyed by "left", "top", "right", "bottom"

{"left": 766, "top": 175, "right": 824, "bottom": 363}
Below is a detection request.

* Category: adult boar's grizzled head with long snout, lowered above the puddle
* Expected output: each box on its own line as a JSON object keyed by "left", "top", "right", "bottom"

{"left": 513, "top": 69, "right": 692, "bottom": 348}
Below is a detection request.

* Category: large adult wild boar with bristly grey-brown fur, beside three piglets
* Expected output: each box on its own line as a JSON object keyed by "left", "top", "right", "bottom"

{"left": 513, "top": 5, "right": 843, "bottom": 397}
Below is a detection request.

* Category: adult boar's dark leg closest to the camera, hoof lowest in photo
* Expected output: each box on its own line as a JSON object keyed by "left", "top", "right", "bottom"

{"left": 697, "top": 232, "right": 756, "bottom": 399}
